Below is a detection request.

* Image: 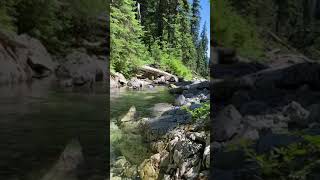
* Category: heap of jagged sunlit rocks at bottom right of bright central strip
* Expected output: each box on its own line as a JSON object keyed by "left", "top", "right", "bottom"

{"left": 139, "top": 127, "right": 210, "bottom": 180}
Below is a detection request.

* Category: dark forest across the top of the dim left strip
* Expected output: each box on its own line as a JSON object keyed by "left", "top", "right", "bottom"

{"left": 0, "top": 0, "right": 108, "bottom": 55}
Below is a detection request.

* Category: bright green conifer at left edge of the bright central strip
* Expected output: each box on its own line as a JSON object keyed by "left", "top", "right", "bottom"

{"left": 110, "top": 0, "right": 150, "bottom": 76}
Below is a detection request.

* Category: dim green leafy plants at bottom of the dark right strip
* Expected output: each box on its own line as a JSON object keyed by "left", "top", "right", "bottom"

{"left": 227, "top": 135, "right": 320, "bottom": 180}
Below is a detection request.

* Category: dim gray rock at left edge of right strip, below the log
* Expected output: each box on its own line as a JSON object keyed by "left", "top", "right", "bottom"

{"left": 213, "top": 105, "right": 242, "bottom": 141}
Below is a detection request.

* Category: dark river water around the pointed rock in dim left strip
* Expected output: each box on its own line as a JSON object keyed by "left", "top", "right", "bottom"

{"left": 0, "top": 80, "right": 109, "bottom": 180}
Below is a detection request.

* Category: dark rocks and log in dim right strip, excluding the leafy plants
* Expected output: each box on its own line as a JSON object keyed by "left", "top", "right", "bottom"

{"left": 211, "top": 56, "right": 320, "bottom": 179}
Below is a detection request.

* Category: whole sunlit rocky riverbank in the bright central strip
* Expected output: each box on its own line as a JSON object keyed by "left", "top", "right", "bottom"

{"left": 111, "top": 81, "right": 210, "bottom": 180}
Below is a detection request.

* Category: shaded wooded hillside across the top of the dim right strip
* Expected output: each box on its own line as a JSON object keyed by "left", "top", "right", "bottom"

{"left": 212, "top": 0, "right": 320, "bottom": 59}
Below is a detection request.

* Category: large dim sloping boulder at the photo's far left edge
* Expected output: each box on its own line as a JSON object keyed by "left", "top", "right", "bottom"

{"left": 0, "top": 30, "right": 56, "bottom": 84}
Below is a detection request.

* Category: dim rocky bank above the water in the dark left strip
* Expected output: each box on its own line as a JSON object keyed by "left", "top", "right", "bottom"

{"left": 0, "top": 30, "right": 107, "bottom": 87}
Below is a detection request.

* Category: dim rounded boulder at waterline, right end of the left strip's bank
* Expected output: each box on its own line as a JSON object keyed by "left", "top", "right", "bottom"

{"left": 56, "top": 52, "right": 107, "bottom": 85}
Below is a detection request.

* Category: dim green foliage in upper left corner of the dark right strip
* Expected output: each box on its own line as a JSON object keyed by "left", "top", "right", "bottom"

{"left": 211, "top": 0, "right": 263, "bottom": 58}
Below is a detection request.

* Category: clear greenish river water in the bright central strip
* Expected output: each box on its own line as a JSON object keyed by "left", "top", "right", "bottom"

{"left": 110, "top": 87, "right": 174, "bottom": 174}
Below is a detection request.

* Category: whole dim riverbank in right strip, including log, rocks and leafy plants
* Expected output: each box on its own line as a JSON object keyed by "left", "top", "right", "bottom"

{"left": 212, "top": 48, "right": 320, "bottom": 180}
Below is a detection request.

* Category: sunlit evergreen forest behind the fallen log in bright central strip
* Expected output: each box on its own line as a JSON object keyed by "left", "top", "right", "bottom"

{"left": 110, "top": 0, "right": 209, "bottom": 79}
